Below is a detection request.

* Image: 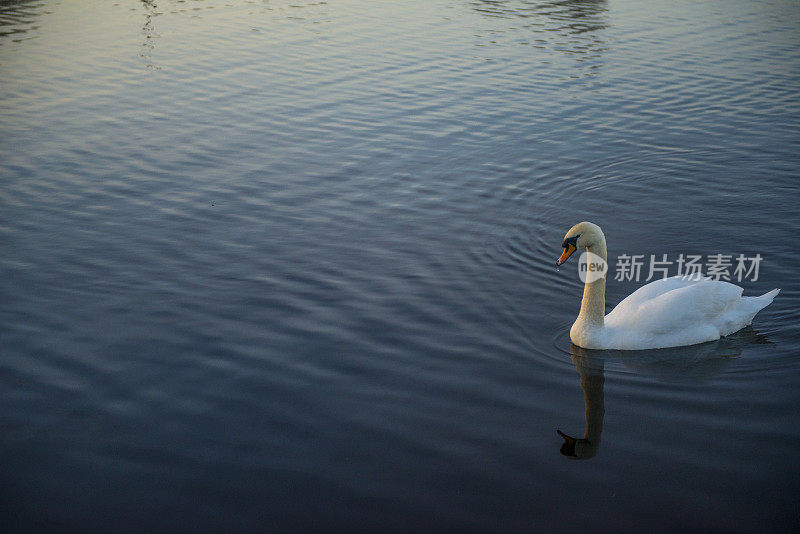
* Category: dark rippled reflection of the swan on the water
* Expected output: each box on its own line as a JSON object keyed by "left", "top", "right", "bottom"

{"left": 556, "top": 326, "right": 768, "bottom": 460}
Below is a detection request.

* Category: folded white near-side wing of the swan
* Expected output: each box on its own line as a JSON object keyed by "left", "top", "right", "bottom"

{"left": 606, "top": 277, "right": 742, "bottom": 339}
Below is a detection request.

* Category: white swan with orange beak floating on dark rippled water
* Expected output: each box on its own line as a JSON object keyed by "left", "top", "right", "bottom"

{"left": 556, "top": 222, "right": 780, "bottom": 350}
